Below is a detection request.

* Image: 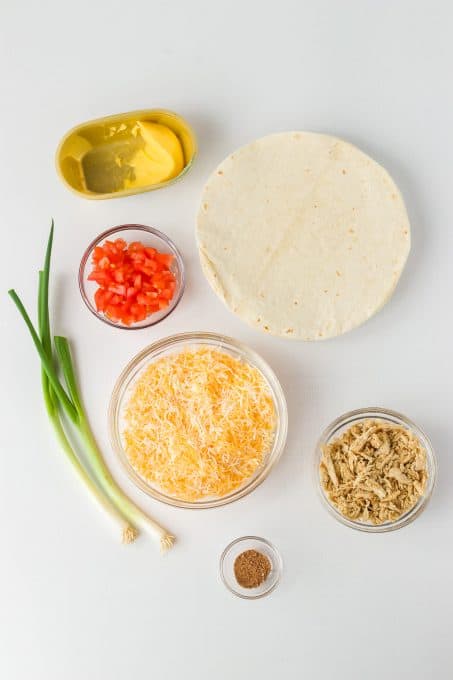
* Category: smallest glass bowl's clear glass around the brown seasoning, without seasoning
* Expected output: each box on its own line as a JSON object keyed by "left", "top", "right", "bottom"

{"left": 219, "top": 536, "right": 283, "bottom": 600}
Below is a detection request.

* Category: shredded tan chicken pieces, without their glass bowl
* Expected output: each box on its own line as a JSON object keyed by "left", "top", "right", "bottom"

{"left": 319, "top": 420, "right": 428, "bottom": 524}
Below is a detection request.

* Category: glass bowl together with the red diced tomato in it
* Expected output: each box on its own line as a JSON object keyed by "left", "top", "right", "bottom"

{"left": 79, "top": 224, "right": 184, "bottom": 329}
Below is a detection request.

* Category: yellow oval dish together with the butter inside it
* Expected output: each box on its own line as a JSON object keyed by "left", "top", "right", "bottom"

{"left": 56, "top": 109, "right": 197, "bottom": 199}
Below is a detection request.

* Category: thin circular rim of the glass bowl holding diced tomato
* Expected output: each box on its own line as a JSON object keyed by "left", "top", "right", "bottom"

{"left": 78, "top": 224, "right": 186, "bottom": 331}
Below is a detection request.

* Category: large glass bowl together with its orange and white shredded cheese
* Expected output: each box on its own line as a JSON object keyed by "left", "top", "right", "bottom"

{"left": 109, "top": 332, "right": 288, "bottom": 508}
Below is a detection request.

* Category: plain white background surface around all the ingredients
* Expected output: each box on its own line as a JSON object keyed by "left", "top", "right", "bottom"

{"left": 0, "top": 0, "right": 453, "bottom": 680}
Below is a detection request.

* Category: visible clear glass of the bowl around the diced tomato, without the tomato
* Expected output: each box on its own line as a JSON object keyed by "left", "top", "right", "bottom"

{"left": 79, "top": 224, "right": 185, "bottom": 331}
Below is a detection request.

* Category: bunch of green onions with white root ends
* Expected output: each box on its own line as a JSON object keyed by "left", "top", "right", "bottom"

{"left": 8, "top": 220, "right": 174, "bottom": 551}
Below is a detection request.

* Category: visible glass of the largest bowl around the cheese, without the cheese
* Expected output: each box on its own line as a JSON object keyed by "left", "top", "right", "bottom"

{"left": 108, "top": 332, "right": 288, "bottom": 508}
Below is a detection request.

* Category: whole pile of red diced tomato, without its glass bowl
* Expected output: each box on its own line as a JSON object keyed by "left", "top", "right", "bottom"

{"left": 88, "top": 238, "right": 176, "bottom": 326}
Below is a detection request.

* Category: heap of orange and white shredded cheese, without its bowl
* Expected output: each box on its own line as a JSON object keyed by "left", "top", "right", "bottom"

{"left": 122, "top": 347, "right": 276, "bottom": 501}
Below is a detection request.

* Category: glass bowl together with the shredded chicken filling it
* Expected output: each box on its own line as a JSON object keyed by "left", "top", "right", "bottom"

{"left": 314, "top": 407, "right": 437, "bottom": 533}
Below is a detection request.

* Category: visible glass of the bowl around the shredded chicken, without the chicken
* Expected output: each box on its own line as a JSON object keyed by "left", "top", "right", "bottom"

{"left": 314, "top": 407, "right": 437, "bottom": 533}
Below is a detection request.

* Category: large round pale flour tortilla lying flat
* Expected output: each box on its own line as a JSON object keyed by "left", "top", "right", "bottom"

{"left": 197, "top": 132, "right": 410, "bottom": 340}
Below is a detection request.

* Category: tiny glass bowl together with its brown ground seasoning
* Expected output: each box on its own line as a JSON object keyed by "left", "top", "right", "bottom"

{"left": 219, "top": 536, "right": 283, "bottom": 600}
